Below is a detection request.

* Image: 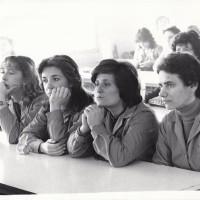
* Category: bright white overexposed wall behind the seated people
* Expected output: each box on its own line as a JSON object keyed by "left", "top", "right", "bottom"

{"left": 0, "top": 0, "right": 200, "bottom": 68}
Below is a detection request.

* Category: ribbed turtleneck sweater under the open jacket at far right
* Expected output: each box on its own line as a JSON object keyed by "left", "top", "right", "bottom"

{"left": 177, "top": 98, "right": 200, "bottom": 141}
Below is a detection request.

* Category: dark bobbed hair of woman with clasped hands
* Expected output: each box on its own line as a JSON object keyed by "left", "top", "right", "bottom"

{"left": 91, "top": 59, "right": 142, "bottom": 107}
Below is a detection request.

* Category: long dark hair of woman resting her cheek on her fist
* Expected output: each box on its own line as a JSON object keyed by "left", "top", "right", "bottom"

{"left": 38, "top": 55, "right": 93, "bottom": 112}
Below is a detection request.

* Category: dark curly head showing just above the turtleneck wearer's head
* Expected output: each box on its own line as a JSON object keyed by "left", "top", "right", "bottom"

{"left": 172, "top": 30, "right": 200, "bottom": 61}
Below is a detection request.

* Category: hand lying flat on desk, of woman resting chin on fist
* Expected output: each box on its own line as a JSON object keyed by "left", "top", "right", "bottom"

{"left": 40, "top": 139, "right": 66, "bottom": 156}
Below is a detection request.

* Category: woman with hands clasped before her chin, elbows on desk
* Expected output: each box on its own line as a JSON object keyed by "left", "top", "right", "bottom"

{"left": 67, "top": 59, "right": 158, "bottom": 167}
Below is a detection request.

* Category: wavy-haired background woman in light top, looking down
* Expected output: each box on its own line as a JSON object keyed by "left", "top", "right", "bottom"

{"left": 133, "top": 28, "right": 162, "bottom": 71}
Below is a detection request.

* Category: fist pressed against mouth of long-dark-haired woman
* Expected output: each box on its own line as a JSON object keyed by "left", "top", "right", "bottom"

{"left": 49, "top": 87, "right": 71, "bottom": 111}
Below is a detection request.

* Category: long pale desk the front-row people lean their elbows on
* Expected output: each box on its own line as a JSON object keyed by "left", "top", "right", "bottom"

{"left": 0, "top": 138, "right": 200, "bottom": 194}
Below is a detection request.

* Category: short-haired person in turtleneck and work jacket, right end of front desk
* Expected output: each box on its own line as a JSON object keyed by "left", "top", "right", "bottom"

{"left": 153, "top": 52, "right": 200, "bottom": 171}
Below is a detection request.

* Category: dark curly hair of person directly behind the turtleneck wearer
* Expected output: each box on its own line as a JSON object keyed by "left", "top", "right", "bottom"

{"left": 172, "top": 30, "right": 200, "bottom": 60}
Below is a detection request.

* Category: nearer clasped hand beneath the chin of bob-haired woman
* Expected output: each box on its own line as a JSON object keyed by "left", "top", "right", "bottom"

{"left": 84, "top": 105, "right": 104, "bottom": 129}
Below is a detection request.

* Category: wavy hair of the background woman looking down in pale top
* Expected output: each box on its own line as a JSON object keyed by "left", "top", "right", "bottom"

{"left": 135, "top": 28, "right": 156, "bottom": 49}
